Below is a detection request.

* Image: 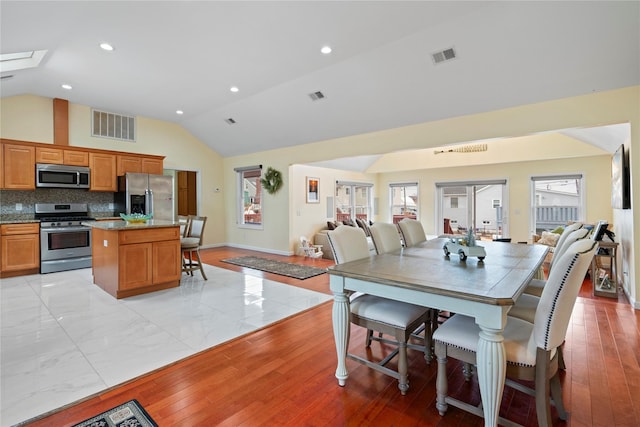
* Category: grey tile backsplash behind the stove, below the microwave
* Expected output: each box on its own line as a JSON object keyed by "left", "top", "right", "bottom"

{"left": 0, "top": 188, "right": 114, "bottom": 216}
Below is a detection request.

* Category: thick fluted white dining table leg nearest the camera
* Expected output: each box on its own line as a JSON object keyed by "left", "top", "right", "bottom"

{"left": 476, "top": 326, "right": 507, "bottom": 426}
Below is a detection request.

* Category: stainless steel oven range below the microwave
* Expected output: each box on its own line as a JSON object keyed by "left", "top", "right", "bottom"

{"left": 35, "top": 203, "right": 93, "bottom": 273}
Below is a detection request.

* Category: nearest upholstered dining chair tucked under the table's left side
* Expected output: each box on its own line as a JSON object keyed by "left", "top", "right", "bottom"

{"left": 327, "top": 225, "right": 431, "bottom": 395}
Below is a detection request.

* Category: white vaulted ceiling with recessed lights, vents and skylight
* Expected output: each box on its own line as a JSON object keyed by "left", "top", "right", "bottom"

{"left": 0, "top": 0, "right": 640, "bottom": 156}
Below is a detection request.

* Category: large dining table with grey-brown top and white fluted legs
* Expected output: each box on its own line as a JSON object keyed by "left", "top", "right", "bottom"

{"left": 328, "top": 236, "right": 549, "bottom": 426}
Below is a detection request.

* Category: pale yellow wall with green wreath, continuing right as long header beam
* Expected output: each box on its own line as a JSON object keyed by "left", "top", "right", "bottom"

{"left": 224, "top": 86, "right": 640, "bottom": 308}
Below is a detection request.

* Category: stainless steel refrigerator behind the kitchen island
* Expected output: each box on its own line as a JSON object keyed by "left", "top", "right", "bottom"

{"left": 115, "top": 173, "right": 175, "bottom": 221}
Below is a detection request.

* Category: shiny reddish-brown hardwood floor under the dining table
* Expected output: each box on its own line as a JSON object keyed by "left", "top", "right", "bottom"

{"left": 20, "top": 248, "right": 640, "bottom": 426}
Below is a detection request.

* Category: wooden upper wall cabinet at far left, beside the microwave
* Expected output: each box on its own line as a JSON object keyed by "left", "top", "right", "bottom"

{"left": 2, "top": 143, "right": 36, "bottom": 190}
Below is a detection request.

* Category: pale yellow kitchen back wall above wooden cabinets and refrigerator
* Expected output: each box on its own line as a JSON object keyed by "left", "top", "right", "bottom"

{"left": 0, "top": 95, "right": 225, "bottom": 245}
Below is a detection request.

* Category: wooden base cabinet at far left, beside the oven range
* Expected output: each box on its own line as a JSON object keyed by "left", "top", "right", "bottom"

{"left": 0, "top": 223, "right": 40, "bottom": 277}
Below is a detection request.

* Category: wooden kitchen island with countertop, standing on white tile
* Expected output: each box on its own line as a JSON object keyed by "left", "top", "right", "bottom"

{"left": 83, "top": 220, "right": 182, "bottom": 298}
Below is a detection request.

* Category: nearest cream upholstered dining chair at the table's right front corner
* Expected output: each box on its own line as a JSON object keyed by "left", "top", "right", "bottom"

{"left": 433, "top": 239, "right": 598, "bottom": 426}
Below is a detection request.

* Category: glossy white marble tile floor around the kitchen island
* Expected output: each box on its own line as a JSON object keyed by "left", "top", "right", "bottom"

{"left": 0, "top": 265, "right": 331, "bottom": 427}
